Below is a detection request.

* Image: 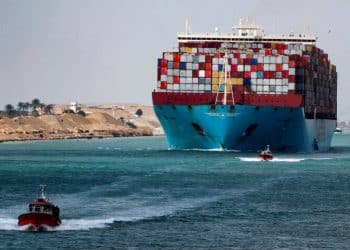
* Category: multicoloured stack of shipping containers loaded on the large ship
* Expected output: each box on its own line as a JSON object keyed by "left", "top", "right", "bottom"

{"left": 158, "top": 42, "right": 337, "bottom": 116}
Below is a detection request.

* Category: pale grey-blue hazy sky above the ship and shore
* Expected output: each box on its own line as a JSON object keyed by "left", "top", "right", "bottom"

{"left": 0, "top": 0, "right": 350, "bottom": 121}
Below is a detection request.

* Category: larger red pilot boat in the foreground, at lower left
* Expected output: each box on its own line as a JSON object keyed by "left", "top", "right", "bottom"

{"left": 18, "top": 185, "right": 61, "bottom": 231}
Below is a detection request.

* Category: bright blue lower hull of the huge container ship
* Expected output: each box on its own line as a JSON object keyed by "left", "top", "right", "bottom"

{"left": 154, "top": 104, "right": 336, "bottom": 152}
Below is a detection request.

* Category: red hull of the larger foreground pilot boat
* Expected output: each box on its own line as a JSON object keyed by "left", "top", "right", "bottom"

{"left": 18, "top": 213, "right": 61, "bottom": 227}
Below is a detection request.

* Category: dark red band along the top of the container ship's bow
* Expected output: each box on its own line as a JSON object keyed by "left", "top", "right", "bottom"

{"left": 152, "top": 88, "right": 302, "bottom": 108}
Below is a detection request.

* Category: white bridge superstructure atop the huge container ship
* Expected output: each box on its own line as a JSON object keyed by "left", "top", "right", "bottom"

{"left": 177, "top": 18, "right": 317, "bottom": 45}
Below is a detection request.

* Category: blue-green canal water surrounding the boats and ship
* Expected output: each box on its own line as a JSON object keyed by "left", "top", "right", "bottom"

{"left": 0, "top": 134, "right": 350, "bottom": 249}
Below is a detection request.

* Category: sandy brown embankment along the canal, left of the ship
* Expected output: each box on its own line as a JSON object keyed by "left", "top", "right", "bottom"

{"left": 0, "top": 106, "right": 162, "bottom": 142}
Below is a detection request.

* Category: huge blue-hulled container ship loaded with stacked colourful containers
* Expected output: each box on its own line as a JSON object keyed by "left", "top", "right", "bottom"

{"left": 152, "top": 19, "right": 337, "bottom": 152}
